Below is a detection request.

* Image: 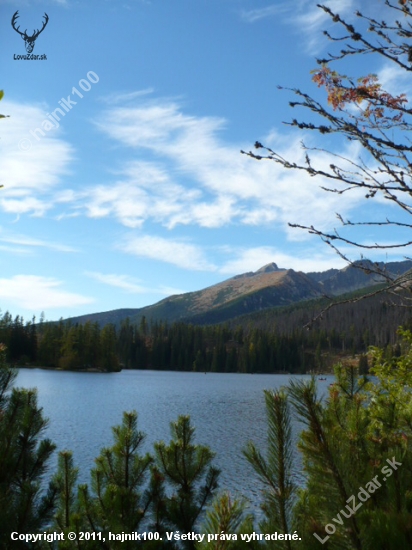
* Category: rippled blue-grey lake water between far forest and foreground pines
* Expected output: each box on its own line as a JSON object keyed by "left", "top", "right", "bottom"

{"left": 16, "top": 369, "right": 331, "bottom": 505}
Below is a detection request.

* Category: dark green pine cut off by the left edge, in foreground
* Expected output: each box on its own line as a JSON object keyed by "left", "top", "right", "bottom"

{"left": 0, "top": 345, "right": 56, "bottom": 550}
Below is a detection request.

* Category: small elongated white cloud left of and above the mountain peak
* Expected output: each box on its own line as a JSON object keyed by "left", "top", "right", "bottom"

{"left": 119, "top": 235, "right": 216, "bottom": 271}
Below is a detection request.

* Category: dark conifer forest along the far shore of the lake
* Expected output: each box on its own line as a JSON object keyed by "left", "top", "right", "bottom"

{"left": 0, "top": 296, "right": 411, "bottom": 373}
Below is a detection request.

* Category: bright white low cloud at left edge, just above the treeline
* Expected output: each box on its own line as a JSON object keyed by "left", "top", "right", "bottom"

{"left": 0, "top": 275, "right": 94, "bottom": 311}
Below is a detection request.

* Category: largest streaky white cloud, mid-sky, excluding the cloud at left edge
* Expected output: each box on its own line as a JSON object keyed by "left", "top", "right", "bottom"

{"left": 84, "top": 101, "right": 356, "bottom": 238}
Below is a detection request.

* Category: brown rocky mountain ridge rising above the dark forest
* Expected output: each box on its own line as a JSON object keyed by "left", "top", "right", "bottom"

{"left": 63, "top": 260, "right": 412, "bottom": 325}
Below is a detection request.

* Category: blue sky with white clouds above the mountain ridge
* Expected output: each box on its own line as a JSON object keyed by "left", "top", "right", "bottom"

{"left": 0, "top": 0, "right": 408, "bottom": 320}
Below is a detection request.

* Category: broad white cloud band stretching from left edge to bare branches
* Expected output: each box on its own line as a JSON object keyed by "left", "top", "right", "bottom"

{"left": 0, "top": 92, "right": 364, "bottom": 242}
